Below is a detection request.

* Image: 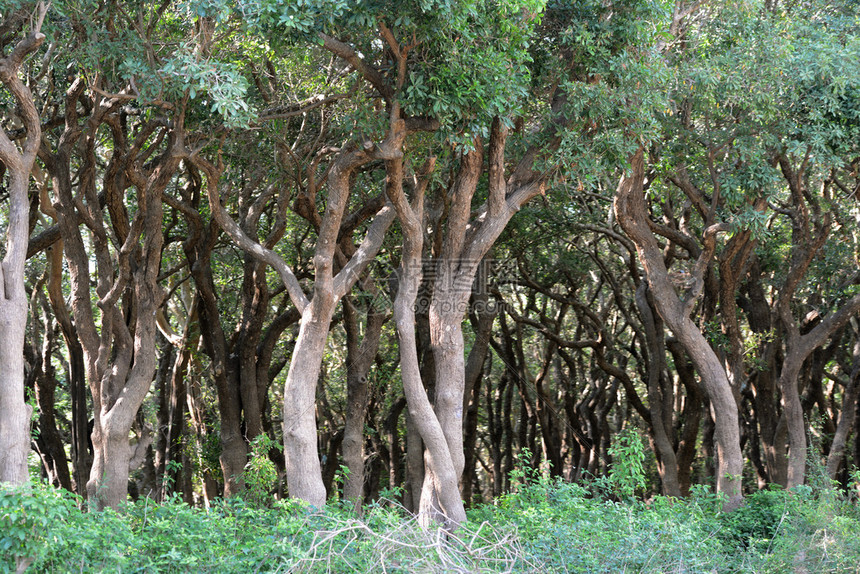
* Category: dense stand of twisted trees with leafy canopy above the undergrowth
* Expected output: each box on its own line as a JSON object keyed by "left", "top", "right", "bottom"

{"left": 0, "top": 0, "right": 860, "bottom": 568}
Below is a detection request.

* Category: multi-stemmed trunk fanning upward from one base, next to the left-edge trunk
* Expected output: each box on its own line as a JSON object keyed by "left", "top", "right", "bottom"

{"left": 43, "top": 80, "right": 182, "bottom": 508}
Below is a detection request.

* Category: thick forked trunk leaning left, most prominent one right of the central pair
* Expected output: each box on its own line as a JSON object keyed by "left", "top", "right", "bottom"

{"left": 615, "top": 148, "right": 743, "bottom": 509}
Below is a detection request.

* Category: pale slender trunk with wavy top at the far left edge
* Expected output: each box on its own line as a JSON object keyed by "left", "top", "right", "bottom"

{"left": 0, "top": 14, "right": 47, "bottom": 484}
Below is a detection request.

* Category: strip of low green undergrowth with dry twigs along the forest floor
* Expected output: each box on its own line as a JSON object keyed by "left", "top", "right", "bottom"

{"left": 0, "top": 479, "right": 860, "bottom": 574}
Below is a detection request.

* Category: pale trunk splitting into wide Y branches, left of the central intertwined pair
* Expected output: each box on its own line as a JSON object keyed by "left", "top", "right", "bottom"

{"left": 192, "top": 120, "right": 396, "bottom": 508}
